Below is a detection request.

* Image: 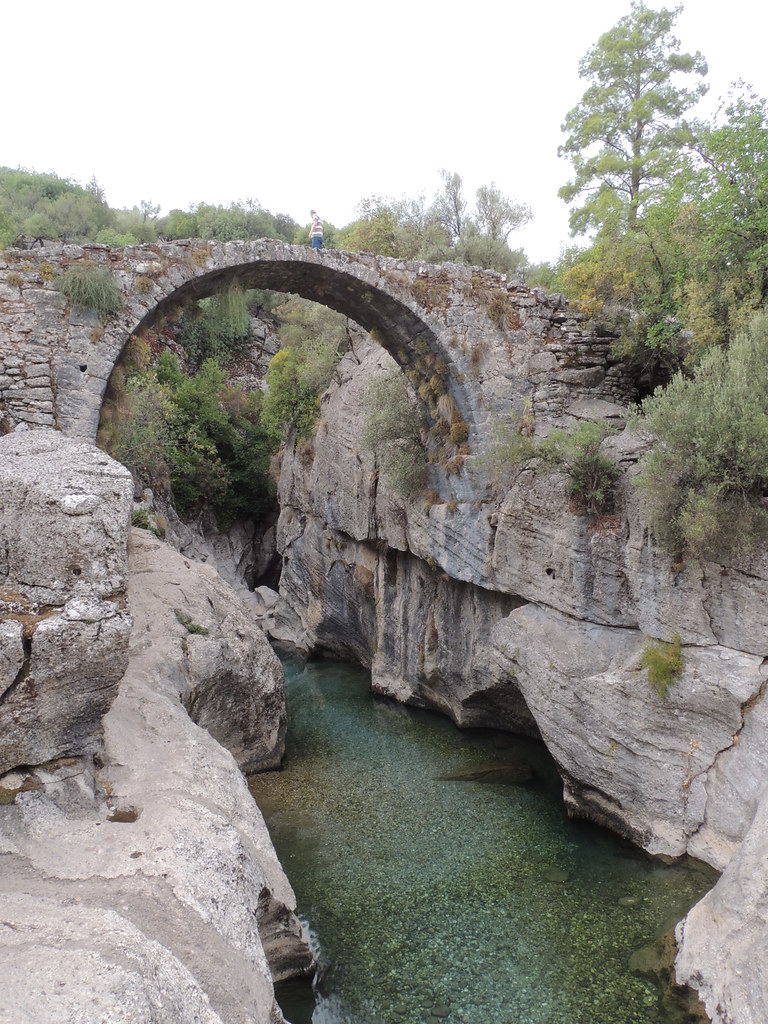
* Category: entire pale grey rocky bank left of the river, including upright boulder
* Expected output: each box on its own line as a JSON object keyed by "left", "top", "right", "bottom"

{"left": 0, "top": 432, "right": 312, "bottom": 1024}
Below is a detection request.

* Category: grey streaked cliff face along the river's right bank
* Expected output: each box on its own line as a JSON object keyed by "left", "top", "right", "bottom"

{"left": 273, "top": 339, "right": 768, "bottom": 1022}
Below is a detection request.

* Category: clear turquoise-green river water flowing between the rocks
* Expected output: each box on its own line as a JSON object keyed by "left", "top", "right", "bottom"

{"left": 251, "top": 662, "right": 716, "bottom": 1024}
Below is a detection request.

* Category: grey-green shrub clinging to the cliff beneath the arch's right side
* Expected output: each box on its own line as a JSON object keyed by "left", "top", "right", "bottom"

{"left": 361, "top": 370, "right": 427, "bottom": 497}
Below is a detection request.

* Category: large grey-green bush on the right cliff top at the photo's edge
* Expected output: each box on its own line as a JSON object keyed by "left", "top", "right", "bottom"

{"left": 631, "top": 313, "right": 768, "bottom": 559}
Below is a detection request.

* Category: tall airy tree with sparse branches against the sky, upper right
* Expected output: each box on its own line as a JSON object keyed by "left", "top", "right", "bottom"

{"left": 558, "top": 0, "right": 708, "bottom": 234}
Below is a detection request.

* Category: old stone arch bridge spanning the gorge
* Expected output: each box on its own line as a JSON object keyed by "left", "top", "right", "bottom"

{"left": 0, "top": 240, "right": 631, "bottom": 442}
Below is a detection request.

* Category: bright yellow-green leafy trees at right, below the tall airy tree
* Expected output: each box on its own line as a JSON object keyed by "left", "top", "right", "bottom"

{"left": 551, "top": 83, "right": 768, "bottom": 385}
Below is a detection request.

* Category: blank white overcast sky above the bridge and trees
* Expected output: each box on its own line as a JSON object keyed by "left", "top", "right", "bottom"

{"left": 6, "top": 0, "right": 768, "bottom": 261}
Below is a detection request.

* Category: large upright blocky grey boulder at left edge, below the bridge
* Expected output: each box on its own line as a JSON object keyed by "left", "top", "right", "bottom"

{"left": 0, "top": 431, "right": 132, "bottom": 774}
